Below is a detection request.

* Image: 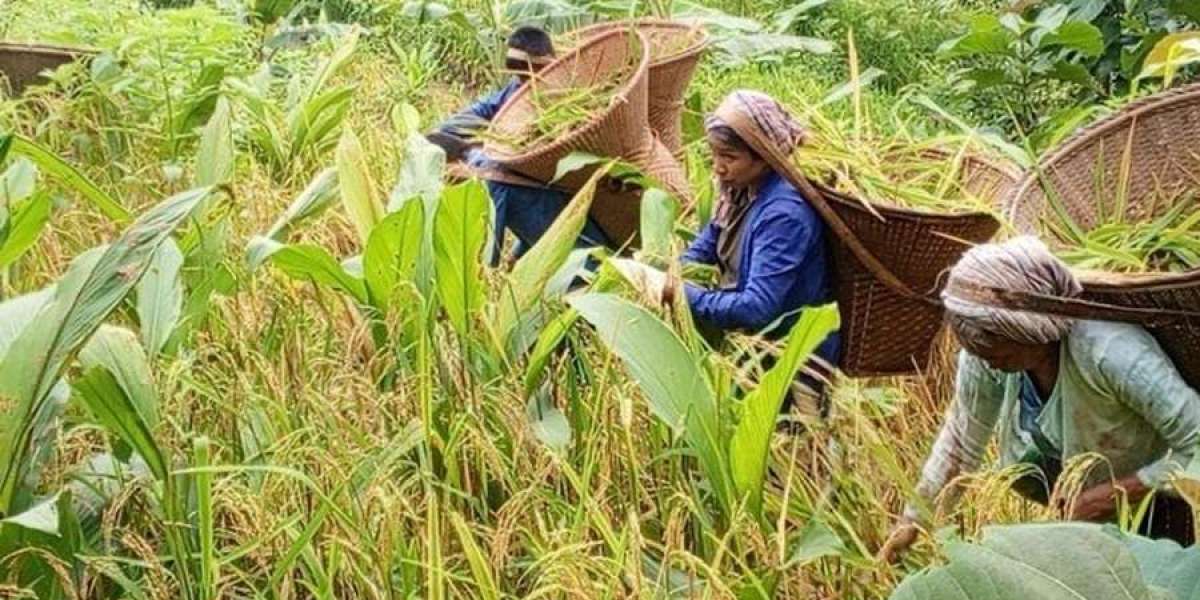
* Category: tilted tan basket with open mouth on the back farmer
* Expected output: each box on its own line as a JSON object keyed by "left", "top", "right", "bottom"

{"left": 485, "top": 30, "right": 691, "bottom": 204}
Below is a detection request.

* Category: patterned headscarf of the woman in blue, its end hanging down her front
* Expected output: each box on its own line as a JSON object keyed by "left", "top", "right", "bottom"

{"left": 704, "top": 90, "right": 808, "bottom": 278}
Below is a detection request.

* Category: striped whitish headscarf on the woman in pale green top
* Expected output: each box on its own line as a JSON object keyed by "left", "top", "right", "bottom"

{"left": 942, "top": 235, "right": 1084, "bottom": 346}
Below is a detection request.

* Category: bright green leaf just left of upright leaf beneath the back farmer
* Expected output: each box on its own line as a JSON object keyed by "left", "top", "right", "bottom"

{"left": 362, "top": 202, "right": 425, "bottom": 312}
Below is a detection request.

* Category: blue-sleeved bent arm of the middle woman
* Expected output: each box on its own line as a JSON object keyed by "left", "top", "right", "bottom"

{"left": 684, "top": 208, "right": 820, "bottom": 331}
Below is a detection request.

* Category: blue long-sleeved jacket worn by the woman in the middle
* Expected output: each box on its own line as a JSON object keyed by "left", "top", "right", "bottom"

{"left": 682, "top": 173, "right": 839, "bottom": 361}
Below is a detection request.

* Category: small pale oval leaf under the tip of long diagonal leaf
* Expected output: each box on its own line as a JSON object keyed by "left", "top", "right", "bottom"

{"left": 137, "top": 239, "right": 184, "bottom": 356}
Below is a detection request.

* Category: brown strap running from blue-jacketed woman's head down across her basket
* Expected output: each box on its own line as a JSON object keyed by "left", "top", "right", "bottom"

{"left": 720, "top": 104, "right": 941, "bottom": 306}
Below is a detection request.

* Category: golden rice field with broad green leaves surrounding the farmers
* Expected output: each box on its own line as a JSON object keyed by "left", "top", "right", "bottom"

{"left": 0, "top": 0, "right": 1200, "bottom": 600}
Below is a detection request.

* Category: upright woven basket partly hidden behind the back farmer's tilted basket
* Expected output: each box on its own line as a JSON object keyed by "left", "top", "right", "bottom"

{"left": 570, "top": 19, "right": 708, "bottom": 156}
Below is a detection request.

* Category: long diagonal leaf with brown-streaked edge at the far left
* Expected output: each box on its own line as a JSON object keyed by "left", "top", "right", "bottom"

{"left": 0, "top": 187, "right": 222, "bottom": 514}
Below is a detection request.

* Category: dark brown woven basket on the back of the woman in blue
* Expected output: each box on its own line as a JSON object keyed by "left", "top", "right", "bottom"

{"left": 818, "top": 186, "right": 1000, "bottom": 377}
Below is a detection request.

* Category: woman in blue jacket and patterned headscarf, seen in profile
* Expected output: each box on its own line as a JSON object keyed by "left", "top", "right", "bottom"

{"left": 619, "top": 90, "right": 839, "bottom": 414}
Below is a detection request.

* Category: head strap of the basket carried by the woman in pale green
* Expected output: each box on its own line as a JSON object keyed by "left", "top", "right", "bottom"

{"left": 946, "top": 281, "right": 1200, "bottom": 326}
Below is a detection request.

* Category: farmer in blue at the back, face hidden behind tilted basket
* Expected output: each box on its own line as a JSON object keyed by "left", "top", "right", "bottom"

{"left": 428, "top": 26, "right": 611, "bottom": 266}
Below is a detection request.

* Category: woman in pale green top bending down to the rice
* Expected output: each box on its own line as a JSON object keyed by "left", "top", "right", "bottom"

{"left": 880, "top": 236, "right": 1200, "bottom": 562}
